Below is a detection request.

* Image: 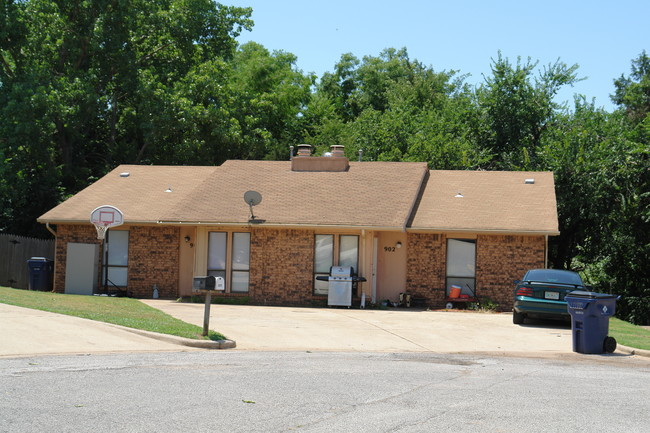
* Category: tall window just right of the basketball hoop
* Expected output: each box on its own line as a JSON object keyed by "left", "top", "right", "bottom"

{"left": 102, "top": 230, "right": 129, "bottom": 288}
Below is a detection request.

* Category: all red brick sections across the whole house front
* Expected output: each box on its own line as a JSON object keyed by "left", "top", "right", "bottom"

{"left": 54, "top": 224, "right": 546, "bottom": 310}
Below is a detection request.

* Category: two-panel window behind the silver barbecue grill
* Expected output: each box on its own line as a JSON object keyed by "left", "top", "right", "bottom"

{"left": 314, "top": 235, "right": 359, "bottom": 295}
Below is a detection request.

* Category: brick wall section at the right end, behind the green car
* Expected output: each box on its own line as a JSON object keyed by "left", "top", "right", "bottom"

{"left": 476, "top": 236, "right": 546, "bottom": 311}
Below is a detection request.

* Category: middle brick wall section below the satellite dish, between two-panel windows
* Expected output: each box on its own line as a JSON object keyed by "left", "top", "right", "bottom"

{"left": 248, "top": 229, "right": 316, "bottom": 305}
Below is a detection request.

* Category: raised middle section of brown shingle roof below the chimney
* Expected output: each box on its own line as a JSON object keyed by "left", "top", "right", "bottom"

{"left": 163, "top": 160, "right": 427, "bottom": 229}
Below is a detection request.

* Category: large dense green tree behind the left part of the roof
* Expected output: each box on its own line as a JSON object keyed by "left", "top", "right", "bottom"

{"left": 0, "top": 0, "right": 252, "bottom": 234}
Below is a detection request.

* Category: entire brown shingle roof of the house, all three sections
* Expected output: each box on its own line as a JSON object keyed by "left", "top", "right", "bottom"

{"left": 39, "top": 160, "right": 558, "bottom": 235}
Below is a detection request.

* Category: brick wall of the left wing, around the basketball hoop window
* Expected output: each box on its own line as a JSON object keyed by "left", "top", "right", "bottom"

{"left": 54, "top": 224, "right": 179, "bottom": 299}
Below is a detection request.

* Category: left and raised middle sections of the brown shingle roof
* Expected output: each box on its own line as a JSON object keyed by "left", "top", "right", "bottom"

{"left": 39, "top": 160, "right": 427, "bottom": 230}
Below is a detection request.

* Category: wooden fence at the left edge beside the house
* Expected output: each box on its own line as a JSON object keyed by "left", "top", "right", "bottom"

{"left": 0, "top": 233, "right": 54, "bottom": 289}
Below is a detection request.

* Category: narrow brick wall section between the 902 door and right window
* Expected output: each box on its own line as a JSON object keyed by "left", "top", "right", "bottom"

{"left": 406, "top": 233, "right": 447, "bottom": 306}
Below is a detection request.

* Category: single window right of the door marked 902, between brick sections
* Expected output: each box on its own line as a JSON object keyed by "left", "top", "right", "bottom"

{"left": 447, "top": 239, "right": 476, "bottom": 296}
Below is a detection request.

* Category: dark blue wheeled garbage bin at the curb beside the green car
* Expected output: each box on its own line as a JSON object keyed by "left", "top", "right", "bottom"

{"left": 564, "top": 290, "right": 620, "bottom": 353}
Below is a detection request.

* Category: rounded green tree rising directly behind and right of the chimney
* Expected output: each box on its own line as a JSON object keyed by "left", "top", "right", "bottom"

{"left": 306, "top": 48, "right": 474, "bottom": 168}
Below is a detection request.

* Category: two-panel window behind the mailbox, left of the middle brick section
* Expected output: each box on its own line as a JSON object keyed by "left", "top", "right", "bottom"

{"left": 208, "top": 232, "right": 251, "bottom": 293}
